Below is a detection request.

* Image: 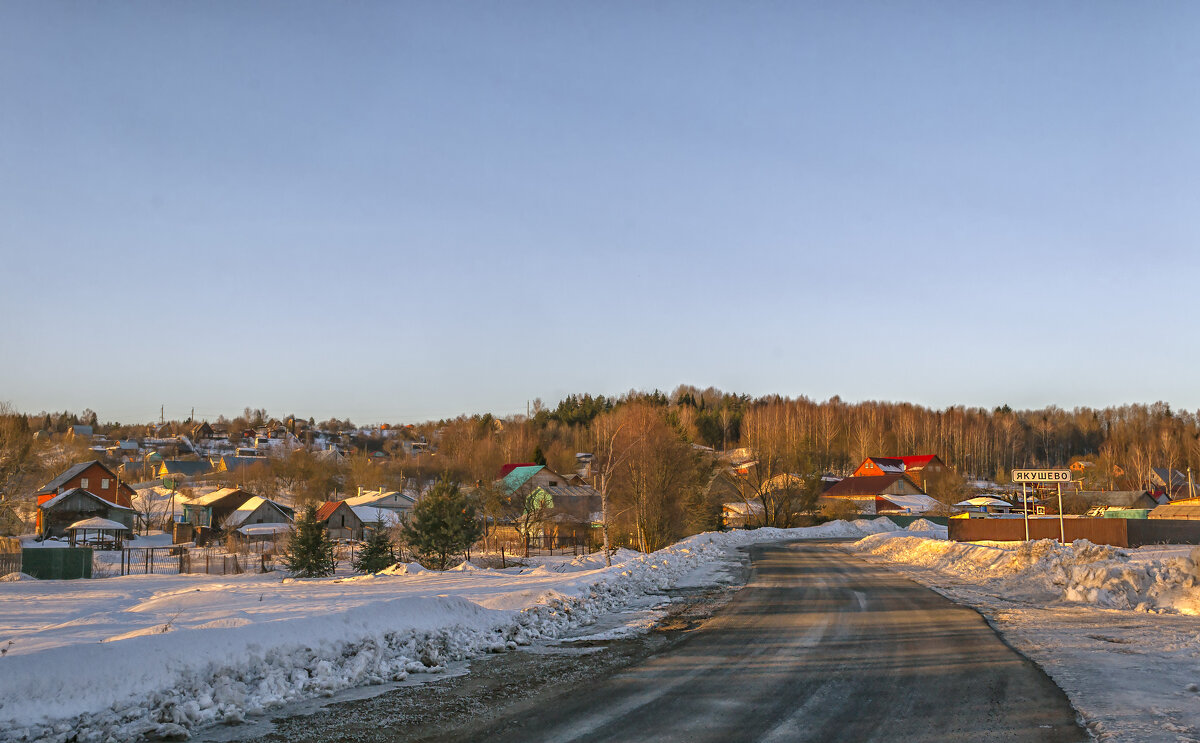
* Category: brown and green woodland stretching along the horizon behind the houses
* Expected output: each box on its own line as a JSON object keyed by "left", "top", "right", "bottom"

{"left": 0, "top": 385, "right": 1200, "bottom": 549}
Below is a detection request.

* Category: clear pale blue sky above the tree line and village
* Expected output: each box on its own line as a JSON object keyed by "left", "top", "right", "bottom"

{"left": 0, "top": 1, "right": 1200, "bottom": 421}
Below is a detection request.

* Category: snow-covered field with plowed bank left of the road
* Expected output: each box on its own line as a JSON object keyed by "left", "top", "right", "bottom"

{"left": 0, "top": 520, "right": 898, "bottom": 741}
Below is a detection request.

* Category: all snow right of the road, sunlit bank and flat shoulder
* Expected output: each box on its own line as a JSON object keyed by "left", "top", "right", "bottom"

{"left": 847, "top": 532, "right": 1200, "bottom": 743}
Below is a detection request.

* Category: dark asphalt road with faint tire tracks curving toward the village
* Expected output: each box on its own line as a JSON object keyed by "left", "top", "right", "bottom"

{"left": 434, "top": 544, "right": 1088, "bottom": 743}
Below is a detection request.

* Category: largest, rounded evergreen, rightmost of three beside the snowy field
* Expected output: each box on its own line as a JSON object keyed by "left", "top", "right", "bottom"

{"left": 403, "top": 478, "right": 484, "bottom": 570}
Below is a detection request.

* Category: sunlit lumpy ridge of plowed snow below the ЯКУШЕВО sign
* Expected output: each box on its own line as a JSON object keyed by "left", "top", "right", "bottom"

{"left": 850, "top": 537, "right": 1200, "bottom": 615}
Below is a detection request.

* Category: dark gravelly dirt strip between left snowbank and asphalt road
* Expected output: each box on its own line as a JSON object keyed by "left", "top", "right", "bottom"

{"left": 257, "top": 568, "right": 745, "bottom": 743}
